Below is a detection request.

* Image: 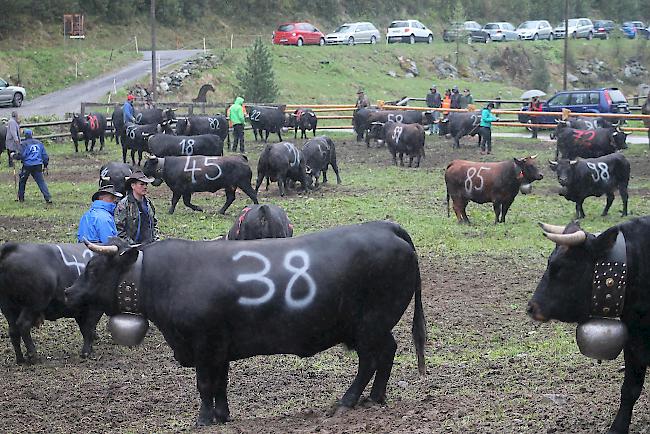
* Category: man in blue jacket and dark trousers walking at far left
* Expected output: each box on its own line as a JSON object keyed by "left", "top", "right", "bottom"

{"left": 11, "top": 129, "right": 52, "bottom": 203}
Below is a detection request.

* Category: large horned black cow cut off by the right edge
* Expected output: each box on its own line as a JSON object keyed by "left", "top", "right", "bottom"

{"left": 528, "top": 217, "right": 650, "bottom": 434}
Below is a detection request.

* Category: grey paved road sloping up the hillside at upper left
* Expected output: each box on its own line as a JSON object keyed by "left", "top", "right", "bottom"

{"left": 0, "top": 50, "right": 202, "bottom": 119}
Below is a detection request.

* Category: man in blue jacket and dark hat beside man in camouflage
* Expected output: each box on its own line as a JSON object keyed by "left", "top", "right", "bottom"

{"left": 77, "top": 185, "right": 122, "bottom": 244}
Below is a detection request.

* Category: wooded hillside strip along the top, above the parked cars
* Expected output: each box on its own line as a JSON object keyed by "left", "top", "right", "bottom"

{"left": 0, "top": 0, "right": 650, "bottom": 39}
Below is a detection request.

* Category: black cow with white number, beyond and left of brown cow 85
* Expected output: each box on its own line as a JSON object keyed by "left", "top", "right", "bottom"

{"left": 370, "top": 121, "right": 425, "bottom": 167}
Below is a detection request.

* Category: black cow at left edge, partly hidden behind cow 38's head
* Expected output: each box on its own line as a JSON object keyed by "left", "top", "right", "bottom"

{"left": 0, "top": 243, "right": 102, "bottom": 363}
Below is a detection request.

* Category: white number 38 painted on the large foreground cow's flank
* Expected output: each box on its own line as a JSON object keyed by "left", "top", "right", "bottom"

{"left": 232, "top": 250, "right": 316, "bottom": 309}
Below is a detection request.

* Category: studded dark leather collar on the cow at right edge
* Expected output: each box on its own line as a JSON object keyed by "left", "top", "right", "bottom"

{"left": 591, "top": 231, "right": 627, "bottom": 318}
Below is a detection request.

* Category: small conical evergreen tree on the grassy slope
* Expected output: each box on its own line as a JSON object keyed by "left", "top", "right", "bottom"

{"left": 236, "top": 38, "right": 278, "bottom": 102}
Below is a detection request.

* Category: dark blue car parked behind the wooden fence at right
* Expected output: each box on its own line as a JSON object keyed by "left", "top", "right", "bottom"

{"left": 518, "top": 87, "right": 630, "bottom": 124}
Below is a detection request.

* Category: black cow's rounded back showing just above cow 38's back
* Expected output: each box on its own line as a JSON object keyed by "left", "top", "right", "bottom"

{"left": 226, "top": 204, "right": 293, "bottom": 240}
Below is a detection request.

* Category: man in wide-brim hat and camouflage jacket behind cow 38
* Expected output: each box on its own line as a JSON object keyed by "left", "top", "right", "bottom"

{"left": 115, "top": 170, "right": 158, "bottom": 244}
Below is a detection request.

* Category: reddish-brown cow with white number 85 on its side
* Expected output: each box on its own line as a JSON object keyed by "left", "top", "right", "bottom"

{"left": 445, "top": 155, "right": 543, "bottom": 223}
